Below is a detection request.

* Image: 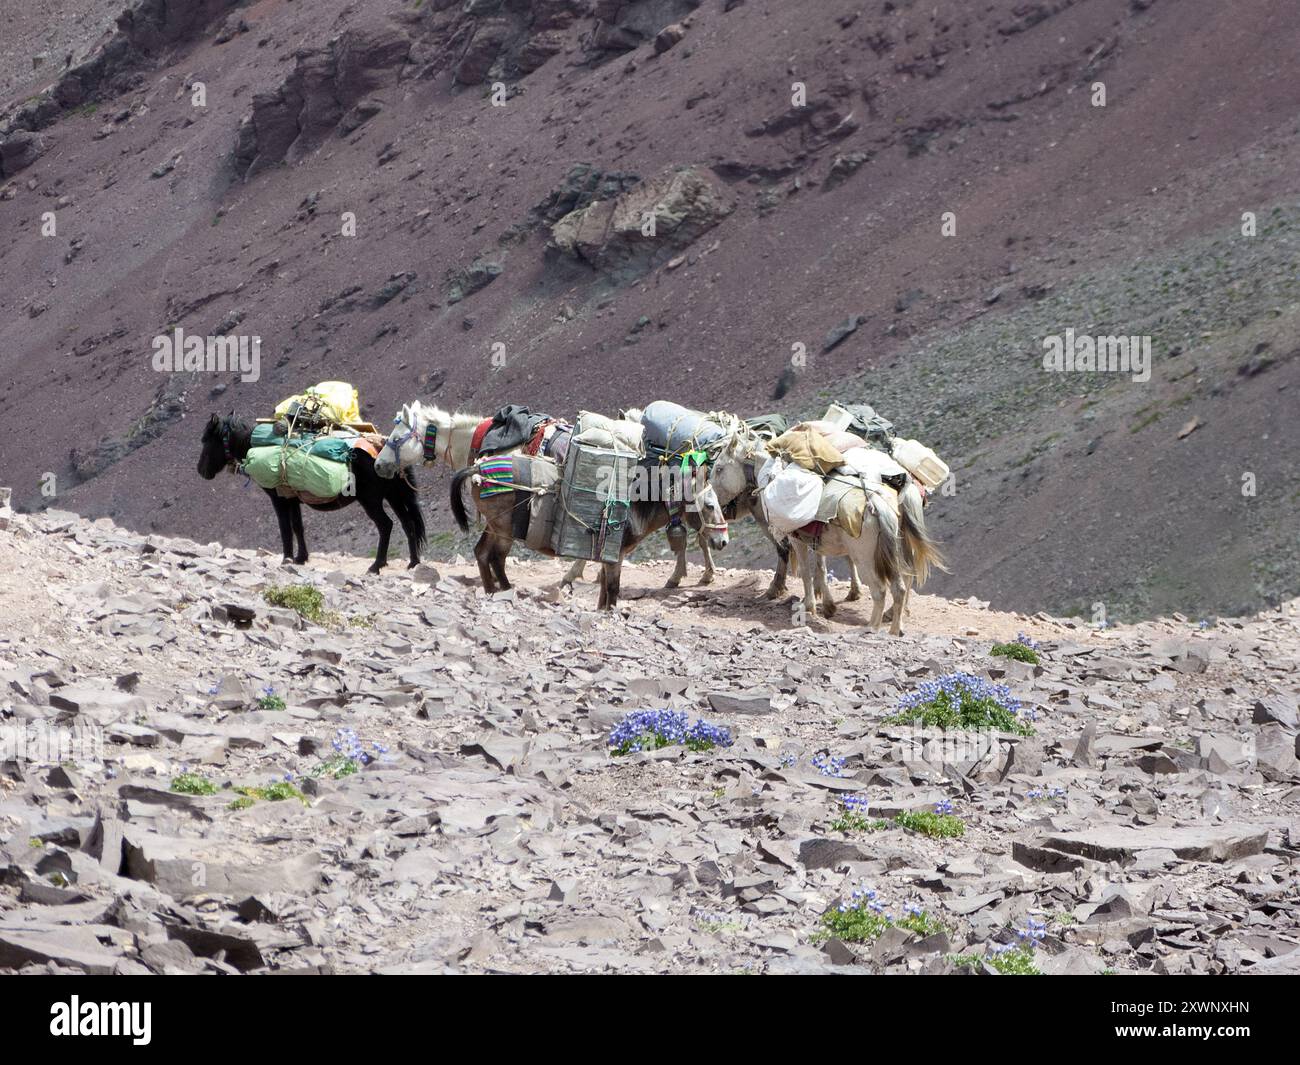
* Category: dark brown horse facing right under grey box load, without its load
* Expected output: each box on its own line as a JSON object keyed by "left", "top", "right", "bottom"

{"left": 451, "top": 456, "right": 727, "bottom": 610}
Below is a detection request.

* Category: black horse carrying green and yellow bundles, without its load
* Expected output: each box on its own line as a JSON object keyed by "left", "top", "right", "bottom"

{"left": 199, "top": 415, "right": 424, "bottom": 573}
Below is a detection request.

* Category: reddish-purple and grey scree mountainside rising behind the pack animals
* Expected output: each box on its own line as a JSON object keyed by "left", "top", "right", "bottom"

{"left": 0, "top": 0, "right": 1300, "bottom": 618}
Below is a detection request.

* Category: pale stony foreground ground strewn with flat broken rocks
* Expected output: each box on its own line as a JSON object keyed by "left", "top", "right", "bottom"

{"left": 0, "top": 499, "right": 1300, "bottom": 974}
